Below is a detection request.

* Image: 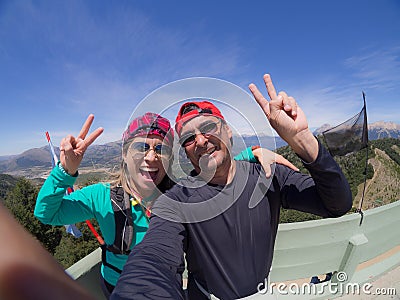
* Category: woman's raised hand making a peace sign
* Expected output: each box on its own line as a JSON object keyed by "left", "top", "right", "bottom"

{"left": 60, "top": 114, "right": 104, "bottom": 176}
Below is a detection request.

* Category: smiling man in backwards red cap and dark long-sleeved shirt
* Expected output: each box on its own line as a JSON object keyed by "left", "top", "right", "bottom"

{"left": 111, "top": 75, "right": 352, "bottom": 300}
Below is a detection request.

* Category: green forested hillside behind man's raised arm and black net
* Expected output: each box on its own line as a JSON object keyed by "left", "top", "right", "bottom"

{"left": 277, "top": 138, "right": 400, "bottom": 223}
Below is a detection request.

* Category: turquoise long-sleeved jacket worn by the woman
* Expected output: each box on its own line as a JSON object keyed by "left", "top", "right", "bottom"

{"left": 34, "top": 148, "right": 257, "bottom": 286}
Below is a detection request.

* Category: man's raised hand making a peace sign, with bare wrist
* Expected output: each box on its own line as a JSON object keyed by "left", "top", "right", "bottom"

{"left": 249, "top": 74, "right": 319, "bottom": 162}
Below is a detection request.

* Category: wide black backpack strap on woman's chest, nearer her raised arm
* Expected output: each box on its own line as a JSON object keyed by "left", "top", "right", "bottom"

{"left": 101, "top": 186, "right": 134, "bottom": 273}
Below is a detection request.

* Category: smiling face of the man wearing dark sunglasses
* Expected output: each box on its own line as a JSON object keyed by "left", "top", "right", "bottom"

{"left": 180, "top": 115, "right": 232, "bottom": 177}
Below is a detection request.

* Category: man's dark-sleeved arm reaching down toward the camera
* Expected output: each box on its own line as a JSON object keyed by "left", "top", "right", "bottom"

{"left": 111, "top": 210, "right": 186, "bottom": 300}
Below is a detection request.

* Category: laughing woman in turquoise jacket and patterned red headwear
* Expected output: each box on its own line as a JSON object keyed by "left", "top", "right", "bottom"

{"left": 34, "top": 113, "right": 295, "bottom": 298}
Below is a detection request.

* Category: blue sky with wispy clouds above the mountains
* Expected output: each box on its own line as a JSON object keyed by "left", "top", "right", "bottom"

{"left": 0, "top": 0, "right": 400, "bottom": 155}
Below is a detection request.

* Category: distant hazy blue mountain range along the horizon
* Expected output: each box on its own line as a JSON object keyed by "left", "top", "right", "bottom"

{"left": 0, "top": 122, "right": 400, "bottom": 177}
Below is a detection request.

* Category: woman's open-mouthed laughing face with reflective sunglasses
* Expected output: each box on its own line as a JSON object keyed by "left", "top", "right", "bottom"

{"left": 124, "top": 135, "right": 172, "bottom": 197}
